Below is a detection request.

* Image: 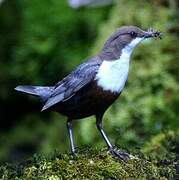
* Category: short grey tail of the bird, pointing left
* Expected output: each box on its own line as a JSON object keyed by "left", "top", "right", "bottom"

{"left": 15, "top": 86, "right": 54, "bottom": 101}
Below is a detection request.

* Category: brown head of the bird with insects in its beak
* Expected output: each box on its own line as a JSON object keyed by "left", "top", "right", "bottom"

{"left": 102, "top": 26, "right": 162, "bottom": 59}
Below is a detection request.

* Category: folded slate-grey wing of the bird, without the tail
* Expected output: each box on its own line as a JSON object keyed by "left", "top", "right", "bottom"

{"left": 42, "top": 61, "right": 100, "bottom": 111}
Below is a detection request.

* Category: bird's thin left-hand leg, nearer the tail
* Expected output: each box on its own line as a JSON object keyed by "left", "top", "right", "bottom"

{"left": 67, "top": 119, "right": 76, "bottom": 155}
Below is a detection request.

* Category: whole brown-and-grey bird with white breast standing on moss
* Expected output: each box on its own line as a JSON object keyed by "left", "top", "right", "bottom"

{"left": 15, "top": 26, "right": 162, "bottom": 160}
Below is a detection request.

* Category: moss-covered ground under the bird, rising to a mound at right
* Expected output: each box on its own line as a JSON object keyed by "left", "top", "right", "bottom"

{"left": 0, "top": 131, "right": 179, "bottom": 180}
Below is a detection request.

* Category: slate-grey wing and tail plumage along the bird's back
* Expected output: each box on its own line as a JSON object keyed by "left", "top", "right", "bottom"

{"left": 15, "top": 56, "right": 101, "bottom": 111}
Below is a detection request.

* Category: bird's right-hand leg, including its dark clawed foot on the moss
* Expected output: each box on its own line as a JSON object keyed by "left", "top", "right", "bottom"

{"left": 96, "top": 114, "right": 130, "bottom": 161}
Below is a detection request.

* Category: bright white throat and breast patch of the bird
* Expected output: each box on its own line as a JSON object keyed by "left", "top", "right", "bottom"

{"left": 95, "top": 38, "right": 144, "bottom": 93}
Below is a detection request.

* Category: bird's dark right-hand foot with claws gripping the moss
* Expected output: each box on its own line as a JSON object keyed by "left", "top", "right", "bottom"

{"left": 109, "top": 149, "right": 132, "bottom": 161}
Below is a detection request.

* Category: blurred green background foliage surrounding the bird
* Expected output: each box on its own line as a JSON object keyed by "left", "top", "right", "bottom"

{"left": 0, "top": 0, "right": 179, "bottom": 162}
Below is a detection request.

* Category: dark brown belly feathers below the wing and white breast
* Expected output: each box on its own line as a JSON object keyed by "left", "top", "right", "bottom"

{"left": 50, "top": 81, "right": 119, "bottom": 119}
